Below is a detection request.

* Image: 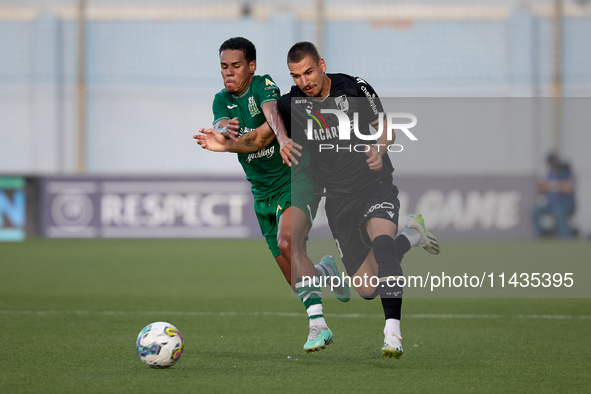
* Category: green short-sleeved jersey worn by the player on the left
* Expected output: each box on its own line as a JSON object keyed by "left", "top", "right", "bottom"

{"left": 213, "top": 75, "right": 290, "bottom": 201}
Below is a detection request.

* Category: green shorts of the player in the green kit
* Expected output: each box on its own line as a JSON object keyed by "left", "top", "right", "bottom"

{"left": 254, "top": 172, "right": 319, "bottom": 257}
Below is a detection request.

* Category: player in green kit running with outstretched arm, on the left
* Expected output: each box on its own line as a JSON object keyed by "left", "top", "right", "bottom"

{"left": 193, "top": 37, "right": 350, "bottom": 352}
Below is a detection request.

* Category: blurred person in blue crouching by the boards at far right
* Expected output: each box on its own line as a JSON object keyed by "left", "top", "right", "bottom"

{"left": 533, "top": 153, "right": 575, "bottom": 239}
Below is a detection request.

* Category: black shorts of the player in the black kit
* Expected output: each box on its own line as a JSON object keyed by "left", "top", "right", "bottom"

{"left": 326, "top": 182, "right": 400, "bottom": 276}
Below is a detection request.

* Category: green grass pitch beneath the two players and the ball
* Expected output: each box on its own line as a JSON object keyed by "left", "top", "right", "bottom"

{"left": 0, "top": 240, "right": 591, "bottom": 393}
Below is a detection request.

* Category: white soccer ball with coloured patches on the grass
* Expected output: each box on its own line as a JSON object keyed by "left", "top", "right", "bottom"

{"left": 135, "top": 321, "right": 183, "bottom": 368}
